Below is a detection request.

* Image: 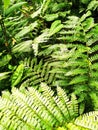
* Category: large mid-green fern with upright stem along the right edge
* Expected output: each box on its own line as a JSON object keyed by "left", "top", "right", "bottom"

{"left": 42, "top": 12, "right": 98, "bottom": 111}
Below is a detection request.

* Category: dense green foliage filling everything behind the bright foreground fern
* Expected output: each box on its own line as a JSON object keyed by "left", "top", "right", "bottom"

{"left": 0, "top": 0, "right": 98, "bottom": 129}
